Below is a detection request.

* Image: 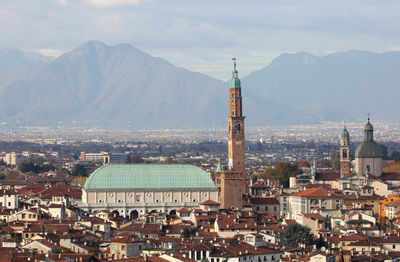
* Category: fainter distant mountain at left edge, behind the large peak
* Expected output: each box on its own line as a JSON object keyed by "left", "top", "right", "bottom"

{"left": 0, "top": 49, "right": 51, "bottom": 75}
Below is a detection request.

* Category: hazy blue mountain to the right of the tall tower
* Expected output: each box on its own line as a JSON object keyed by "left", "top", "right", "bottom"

{"left": 242, "top": 51, "right": 400, "bottom": 121}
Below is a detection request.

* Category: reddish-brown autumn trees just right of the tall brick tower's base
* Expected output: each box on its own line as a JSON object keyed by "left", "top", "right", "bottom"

{"left": 257, "top": 162, "right": 300, "bottom": 187}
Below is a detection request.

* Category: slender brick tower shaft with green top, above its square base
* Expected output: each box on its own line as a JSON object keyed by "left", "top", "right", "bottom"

{"left": 228, "top": 58, "right": 246, "bottom": 174}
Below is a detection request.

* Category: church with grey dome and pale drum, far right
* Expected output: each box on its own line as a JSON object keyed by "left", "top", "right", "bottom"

{"left": 355, "top": 118, "right": 383, "bottom": 177}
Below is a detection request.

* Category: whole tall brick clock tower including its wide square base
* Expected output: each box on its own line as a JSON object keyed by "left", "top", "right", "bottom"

{"left": 216, "top": 58, "right": 247, "bottom": 209}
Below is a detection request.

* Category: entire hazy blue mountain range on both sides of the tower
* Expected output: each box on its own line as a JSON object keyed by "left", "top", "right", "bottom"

{"left": 0, "top": 41, "right": 400, "bottom": 129}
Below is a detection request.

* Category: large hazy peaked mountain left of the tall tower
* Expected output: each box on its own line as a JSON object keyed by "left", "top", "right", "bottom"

{"left": 0, "top": 41, "right": 225, "bottom": 128}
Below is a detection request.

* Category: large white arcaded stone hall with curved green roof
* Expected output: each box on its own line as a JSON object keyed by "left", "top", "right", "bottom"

{"left": 80, "top": 164, "right": 219, "bottom": 218}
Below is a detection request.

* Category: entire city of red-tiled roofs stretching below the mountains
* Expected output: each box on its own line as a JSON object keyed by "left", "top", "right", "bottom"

{"left": 0, "top": 59, "right": 400, "bottom": 262}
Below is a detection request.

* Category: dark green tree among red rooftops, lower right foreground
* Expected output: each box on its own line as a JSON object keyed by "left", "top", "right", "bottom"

{"left": 281, "top": 223, "right": 314, "bottom": 248}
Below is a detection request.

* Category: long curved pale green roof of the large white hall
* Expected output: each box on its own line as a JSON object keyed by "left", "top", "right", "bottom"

{"left": 84, "top": 164, "right": 215, "bottom": 190}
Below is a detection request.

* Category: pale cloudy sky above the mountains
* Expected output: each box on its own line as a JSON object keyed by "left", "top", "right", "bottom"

{"left": 0, "top": 0, "right": 400, "bottom": 80}
